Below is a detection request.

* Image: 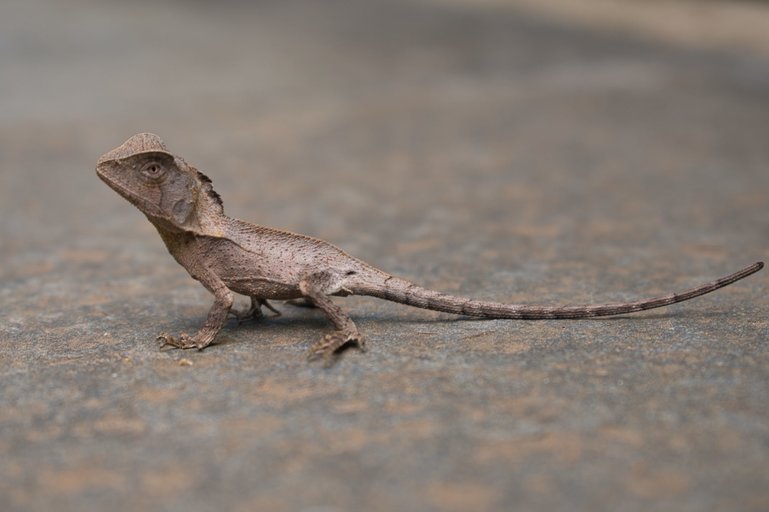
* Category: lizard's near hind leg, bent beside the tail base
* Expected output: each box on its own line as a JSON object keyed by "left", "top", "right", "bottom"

{"left": 299, "top": 273, "right": 365, "bottom": 361}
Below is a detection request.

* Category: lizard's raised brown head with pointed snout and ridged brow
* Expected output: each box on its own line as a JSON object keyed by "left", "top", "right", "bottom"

{"left": 96, "top": 133, "right": 222, "bottom": 229}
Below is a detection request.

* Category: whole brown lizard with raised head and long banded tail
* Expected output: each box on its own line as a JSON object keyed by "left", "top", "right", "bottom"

{"left": 96, "top": 133, "right": 763, "bottom": 357}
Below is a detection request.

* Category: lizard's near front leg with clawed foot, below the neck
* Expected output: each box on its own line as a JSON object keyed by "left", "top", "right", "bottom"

{"left": 157, "top": 269, "right": 234, "bottom": 350}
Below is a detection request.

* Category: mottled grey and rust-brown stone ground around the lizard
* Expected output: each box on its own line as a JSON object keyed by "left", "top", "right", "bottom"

{"left": 0, "top": 0, "right": 769, "bottom": 512}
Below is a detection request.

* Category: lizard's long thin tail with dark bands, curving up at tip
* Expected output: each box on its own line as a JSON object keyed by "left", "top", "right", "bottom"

{"left": 355, "top": 261, "right": 764, "bottom": 320}
